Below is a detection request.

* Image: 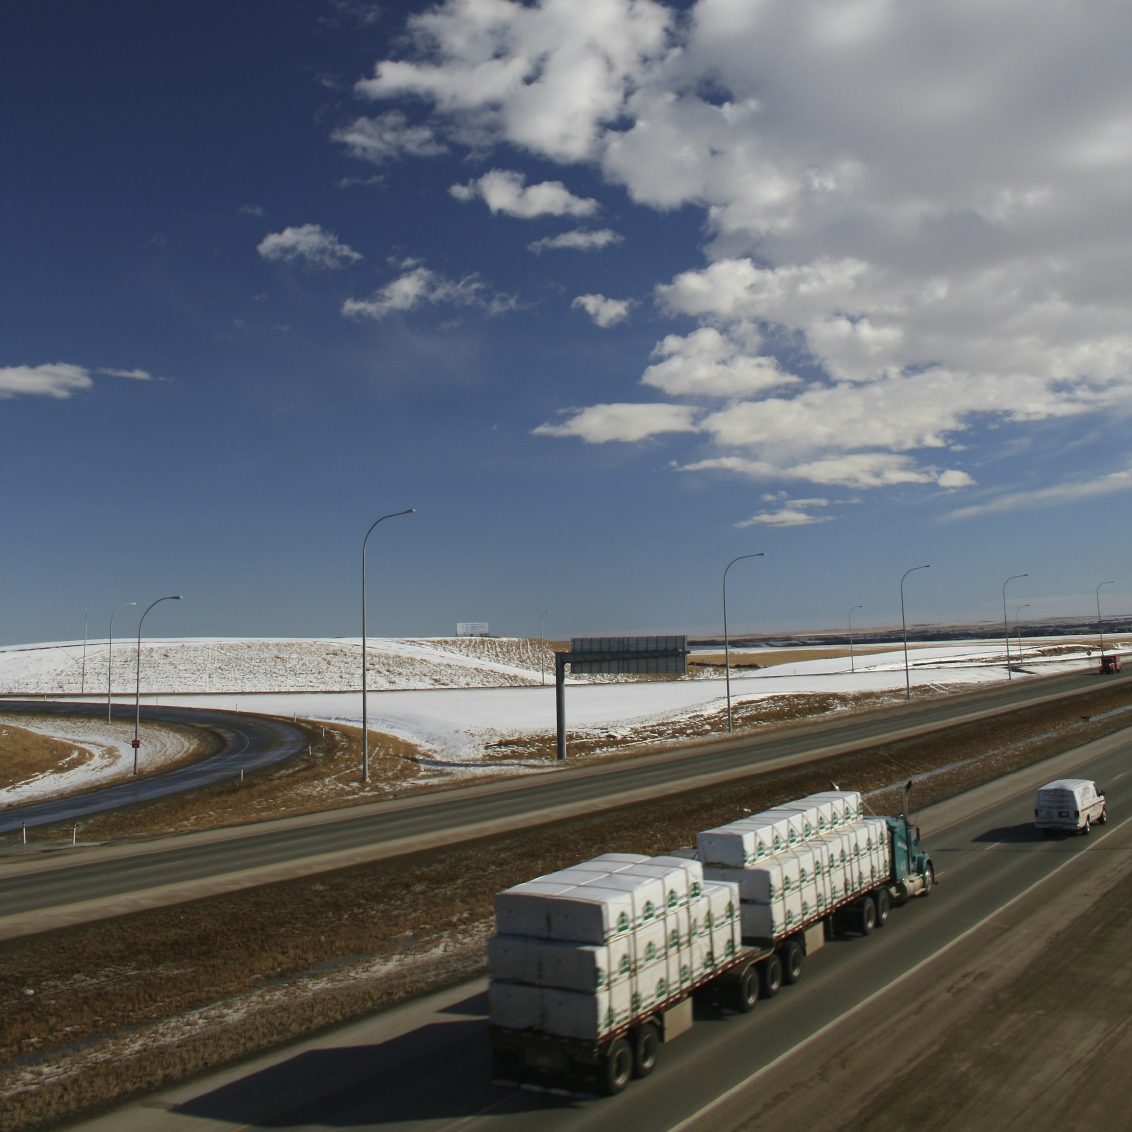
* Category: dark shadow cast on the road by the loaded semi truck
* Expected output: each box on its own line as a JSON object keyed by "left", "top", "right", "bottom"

{"left": 174, "top": 994, "right": 590, "bottom": 1127}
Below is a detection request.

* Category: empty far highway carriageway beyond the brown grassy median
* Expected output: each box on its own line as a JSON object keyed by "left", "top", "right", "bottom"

{"left": 0, "top": 676, "right": 1113, "bottom": 938}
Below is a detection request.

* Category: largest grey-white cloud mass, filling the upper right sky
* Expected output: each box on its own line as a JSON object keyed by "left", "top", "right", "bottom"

{"left": 357, "top": 0, "right": 1132, "bottom": 516}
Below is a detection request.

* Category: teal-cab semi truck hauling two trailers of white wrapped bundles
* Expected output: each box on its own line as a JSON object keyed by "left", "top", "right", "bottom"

{"left": 488, "top": 789, "right": 935, "bottom": 1095}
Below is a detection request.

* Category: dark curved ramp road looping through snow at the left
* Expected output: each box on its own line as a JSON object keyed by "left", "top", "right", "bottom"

{"left": 0, "top": 700, "right": 310, "bottom": 833}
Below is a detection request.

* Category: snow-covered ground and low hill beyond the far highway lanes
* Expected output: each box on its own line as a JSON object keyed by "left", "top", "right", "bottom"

{"left": 0, "top": 637, "right": 1113, "bottom": 806}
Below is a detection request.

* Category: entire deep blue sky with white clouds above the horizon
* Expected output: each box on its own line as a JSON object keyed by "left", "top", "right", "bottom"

{"left": 0, "top": 0, "right": 1132, "bottom": 643}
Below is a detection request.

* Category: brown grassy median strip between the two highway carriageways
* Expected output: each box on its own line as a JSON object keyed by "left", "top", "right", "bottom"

{"left": 0, "top": 680, "right": 1132, "bottom": 1129}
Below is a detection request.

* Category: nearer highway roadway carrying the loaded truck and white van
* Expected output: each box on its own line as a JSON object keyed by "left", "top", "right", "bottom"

{"left": 73, "top": 731, "right": 1132, "bottom": 1132}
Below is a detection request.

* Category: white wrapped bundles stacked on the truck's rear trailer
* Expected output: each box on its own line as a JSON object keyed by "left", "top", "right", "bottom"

{"left": 488, "top": 854, "right": 741, "bottom": 1039}
